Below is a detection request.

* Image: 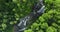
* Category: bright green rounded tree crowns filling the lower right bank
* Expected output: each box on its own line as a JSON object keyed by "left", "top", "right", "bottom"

{"left": 24, "top": 10, "right": 60, "bottom": 32}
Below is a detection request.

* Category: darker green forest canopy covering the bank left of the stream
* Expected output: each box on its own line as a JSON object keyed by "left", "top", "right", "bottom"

{"left": 0, "top": 0, "right": 37, "bottom": 32}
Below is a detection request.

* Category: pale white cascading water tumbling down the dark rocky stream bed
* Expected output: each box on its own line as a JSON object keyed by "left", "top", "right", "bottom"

{"left": 16, "top": 0, "right": 45, "bottom": 32}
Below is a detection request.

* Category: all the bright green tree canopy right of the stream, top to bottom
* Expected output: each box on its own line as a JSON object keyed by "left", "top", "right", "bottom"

{"left": 24, "top": 0, "right": 60, "bottom": 32}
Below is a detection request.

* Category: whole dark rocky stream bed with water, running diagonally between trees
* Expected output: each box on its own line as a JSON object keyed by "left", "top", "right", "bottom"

{"left": 14, "top": 0, "right": 45, "bottom": 32}
